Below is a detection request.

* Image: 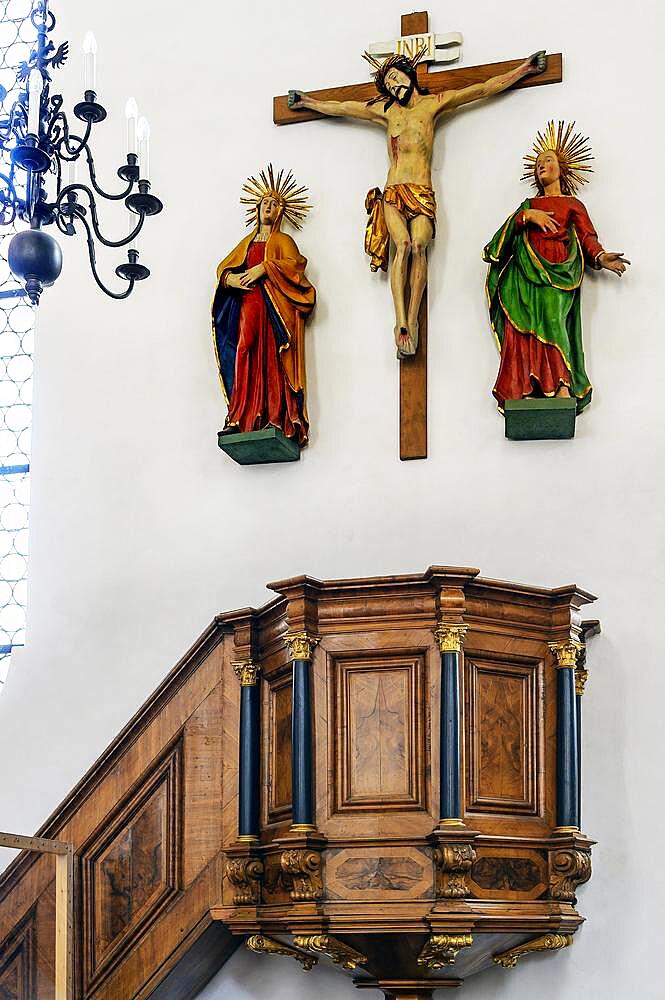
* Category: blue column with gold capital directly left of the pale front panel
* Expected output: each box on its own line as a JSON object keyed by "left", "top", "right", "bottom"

{"left": 284, "top": 632, "right": 319, "bottom": 833}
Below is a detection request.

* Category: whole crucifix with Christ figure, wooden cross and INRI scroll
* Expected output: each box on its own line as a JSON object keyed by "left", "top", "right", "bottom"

{"left": 274, "top": 11, "right": 562, "bottom": 460}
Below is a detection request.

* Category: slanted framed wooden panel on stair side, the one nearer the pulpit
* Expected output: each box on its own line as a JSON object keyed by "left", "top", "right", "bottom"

{"left": 81, "top": 741, "right": 182, "bottom": 993}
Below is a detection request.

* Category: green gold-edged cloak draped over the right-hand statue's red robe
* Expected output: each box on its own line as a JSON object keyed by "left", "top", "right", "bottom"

{"left": 483, "top": 198, "right": 591, "bottom": 413}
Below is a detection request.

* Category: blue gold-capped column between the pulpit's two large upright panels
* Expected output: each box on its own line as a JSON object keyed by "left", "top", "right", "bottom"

{"left": 434, "top": 622, "right": 468, "bottom": 826}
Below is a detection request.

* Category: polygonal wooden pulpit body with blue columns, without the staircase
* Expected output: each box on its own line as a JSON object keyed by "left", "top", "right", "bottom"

{"left": 212, "top": 566, "right": 598, "bottom": 1000}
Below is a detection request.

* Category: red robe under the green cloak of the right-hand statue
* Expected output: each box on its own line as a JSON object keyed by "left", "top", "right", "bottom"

{"left": 493, "top": 196, "right": 603, "bottom": 408}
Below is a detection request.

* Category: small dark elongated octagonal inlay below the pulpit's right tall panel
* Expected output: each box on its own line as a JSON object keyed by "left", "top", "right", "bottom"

{"left": 467, "top": 847, "right": 548, "bottom": 899}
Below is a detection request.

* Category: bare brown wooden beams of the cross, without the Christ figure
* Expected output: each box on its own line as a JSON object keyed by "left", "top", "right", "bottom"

{"left": 273, "top": 11, "right": 562, "bottom": 461}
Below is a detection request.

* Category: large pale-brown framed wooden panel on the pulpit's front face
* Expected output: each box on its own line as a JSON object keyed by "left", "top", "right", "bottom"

{"left": 333, "top": 652, "right": 426, "bottom": 812}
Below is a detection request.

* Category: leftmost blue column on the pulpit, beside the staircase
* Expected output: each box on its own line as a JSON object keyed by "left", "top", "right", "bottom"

{"left": 234, "top": 661, "right": 261, "bottom": 842}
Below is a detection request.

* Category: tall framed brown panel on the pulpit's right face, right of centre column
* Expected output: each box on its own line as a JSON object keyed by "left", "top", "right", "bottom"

{"left": 466, "top": 657, "right": 542, "bottom": 814}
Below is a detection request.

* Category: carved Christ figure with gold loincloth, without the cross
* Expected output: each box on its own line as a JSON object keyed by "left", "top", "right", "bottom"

{"left": 289, "top": 49, "right": 546, "bottom": 358}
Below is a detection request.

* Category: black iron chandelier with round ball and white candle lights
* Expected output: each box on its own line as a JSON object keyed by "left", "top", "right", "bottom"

{"left": 0, "top": 0, "right": 163, "bottom": 305}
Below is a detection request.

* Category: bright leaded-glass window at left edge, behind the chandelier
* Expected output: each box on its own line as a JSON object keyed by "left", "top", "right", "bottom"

{"left": 0, "top": 0, "right": 37, "bottom": 691}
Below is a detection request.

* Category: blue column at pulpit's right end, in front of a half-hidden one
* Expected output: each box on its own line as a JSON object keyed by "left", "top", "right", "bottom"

{"left": 550, "top": 639, "right": 582, "bottom": 833}
